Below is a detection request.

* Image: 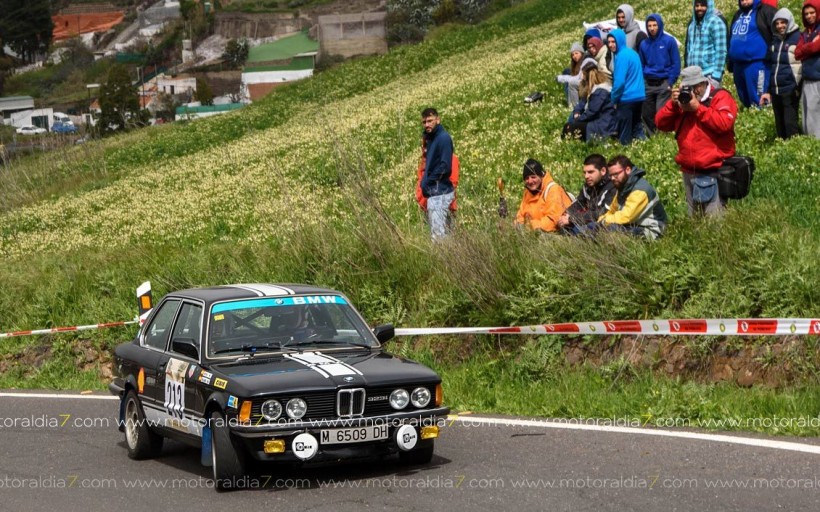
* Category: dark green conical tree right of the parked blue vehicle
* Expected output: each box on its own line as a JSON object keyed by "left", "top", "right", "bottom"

{"left": 99, "top": 64, "right": 141, "bottom": 133}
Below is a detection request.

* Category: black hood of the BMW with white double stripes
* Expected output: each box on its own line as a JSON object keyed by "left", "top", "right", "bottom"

{"left": 211, "top": 350, "right": 441, "bottom": 397}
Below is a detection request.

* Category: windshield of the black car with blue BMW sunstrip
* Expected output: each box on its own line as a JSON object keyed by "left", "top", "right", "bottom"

{"left": 207, "top": 295, "right": 377, "bottom": 357}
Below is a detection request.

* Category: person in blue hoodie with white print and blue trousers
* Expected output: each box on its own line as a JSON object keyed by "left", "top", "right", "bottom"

{"left": 728, "top": 0, "right": 776, "bottom": 108}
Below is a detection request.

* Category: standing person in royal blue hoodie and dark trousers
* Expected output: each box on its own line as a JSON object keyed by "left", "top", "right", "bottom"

{"left": 638, "top": 14, "right": 680, "bottom": 135}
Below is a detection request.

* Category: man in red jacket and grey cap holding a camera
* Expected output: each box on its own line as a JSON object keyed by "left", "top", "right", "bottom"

{"left": 655, "top": 66, "right": 737, "bottom": 215}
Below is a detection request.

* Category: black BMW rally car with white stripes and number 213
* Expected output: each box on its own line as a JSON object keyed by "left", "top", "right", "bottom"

{"left": 109, "top": 284, "right": 449, "bottom": 489}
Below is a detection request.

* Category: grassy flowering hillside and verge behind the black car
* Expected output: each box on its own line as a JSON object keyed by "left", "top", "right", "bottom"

{"left": 0, "top": 0, "right": 820, "bottom": 435}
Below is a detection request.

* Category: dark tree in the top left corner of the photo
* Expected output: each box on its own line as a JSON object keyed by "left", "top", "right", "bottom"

{"left": 0, "top": 0, "right": 54, "bottom": 62}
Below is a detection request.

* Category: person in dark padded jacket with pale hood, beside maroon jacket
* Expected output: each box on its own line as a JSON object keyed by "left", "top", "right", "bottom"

{"left": 760, "top": 7, "right": 803, "bottom": 139}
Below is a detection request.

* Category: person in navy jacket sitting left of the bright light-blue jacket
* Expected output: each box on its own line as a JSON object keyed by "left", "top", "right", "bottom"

{"left": 562, "top": 58, "right": 617, "bottom": 142}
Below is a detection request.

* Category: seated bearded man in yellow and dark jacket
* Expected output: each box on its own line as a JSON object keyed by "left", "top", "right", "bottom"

{"left": 598, "top": 155, "right": 667, "bottom": 240}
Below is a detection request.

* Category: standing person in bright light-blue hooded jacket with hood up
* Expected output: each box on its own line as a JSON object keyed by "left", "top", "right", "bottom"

{"left": 606, "top": 28, "right": 646, "bottom": 146}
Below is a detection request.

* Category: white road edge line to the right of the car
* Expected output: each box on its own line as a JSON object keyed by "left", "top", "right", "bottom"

{"left": 456, "top": 415, "right": 820, "bottom": 454}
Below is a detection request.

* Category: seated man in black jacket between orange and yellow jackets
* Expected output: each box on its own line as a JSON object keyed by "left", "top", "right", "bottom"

{"left": 558, "top": 153, "right": 615, "bottom": 234}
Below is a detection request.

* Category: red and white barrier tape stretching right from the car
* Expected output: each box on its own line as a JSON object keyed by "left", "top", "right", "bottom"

{"left": 396, "top": 318, "right": 820, "bottom": 336}
